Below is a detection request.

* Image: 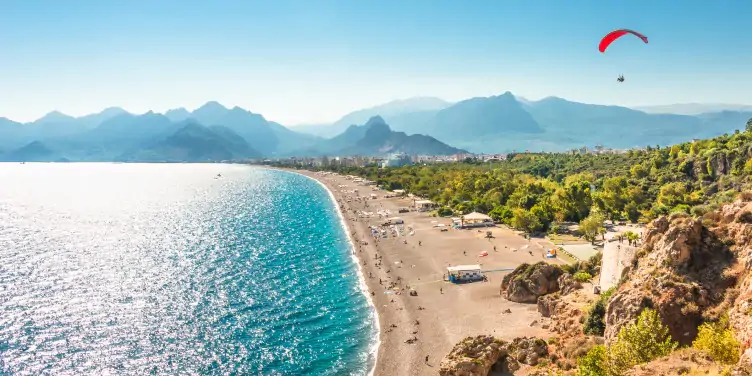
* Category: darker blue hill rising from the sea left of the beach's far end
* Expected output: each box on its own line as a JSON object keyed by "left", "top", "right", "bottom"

{"left": 117, "top": 120, "right": 261, "bottom": 162}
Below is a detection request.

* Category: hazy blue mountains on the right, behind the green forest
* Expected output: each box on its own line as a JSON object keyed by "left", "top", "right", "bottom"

{"left": 293, "top": 92, "right": 752, "bottom": 153}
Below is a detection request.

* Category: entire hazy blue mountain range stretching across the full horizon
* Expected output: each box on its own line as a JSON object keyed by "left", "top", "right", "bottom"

{"left": 0, "top": 92, "right": 752, "bottom": 161}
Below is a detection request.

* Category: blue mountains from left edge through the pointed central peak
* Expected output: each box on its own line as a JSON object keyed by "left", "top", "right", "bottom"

{"left": 0, "top": 102, "right": 466, "bottom": 162}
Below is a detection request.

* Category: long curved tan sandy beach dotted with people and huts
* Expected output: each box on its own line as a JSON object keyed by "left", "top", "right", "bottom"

{"left": 286, "top": 171, "right": 558, "bottom": 376}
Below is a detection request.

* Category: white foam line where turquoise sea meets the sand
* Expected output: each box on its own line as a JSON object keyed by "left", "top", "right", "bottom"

{"left": 294, "top": 169, "right": 381, "bottom": 376}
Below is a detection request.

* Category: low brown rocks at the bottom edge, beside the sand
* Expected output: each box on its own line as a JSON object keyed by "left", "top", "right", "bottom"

{"left": 439, "top": 335, "right": 548, "bottom": 376}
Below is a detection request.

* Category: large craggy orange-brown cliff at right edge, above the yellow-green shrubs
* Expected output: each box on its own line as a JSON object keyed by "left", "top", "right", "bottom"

{"left": 605, "top": 200, "right": 752, "bottom": 369}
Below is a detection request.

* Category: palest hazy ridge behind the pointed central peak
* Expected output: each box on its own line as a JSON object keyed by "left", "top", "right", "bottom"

{"left": 294, "top": 97, "right": 451, "bottom": 137}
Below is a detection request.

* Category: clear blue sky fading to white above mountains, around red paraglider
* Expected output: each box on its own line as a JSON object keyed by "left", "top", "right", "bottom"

{"left": 0, "top": 0, "right": 752, "bottom": 125}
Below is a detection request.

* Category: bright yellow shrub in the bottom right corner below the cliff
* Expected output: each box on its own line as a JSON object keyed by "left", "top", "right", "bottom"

{"left": 692, "top": 317, "right": 741, "bottom": 364}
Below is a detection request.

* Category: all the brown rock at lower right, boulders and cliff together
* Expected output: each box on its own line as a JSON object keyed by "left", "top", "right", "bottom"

{"left": 442, "top": 195, "right": 752, "bottom": 375}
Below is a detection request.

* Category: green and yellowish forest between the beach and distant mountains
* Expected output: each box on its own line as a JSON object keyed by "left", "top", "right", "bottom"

{"left": 286, "top": 119, "right": 752, "bottom": 232}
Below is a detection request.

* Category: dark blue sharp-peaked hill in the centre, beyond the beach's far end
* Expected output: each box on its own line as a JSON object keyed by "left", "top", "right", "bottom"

{"left": 300, "top": 116, "right": 466, "bottom": 156}
